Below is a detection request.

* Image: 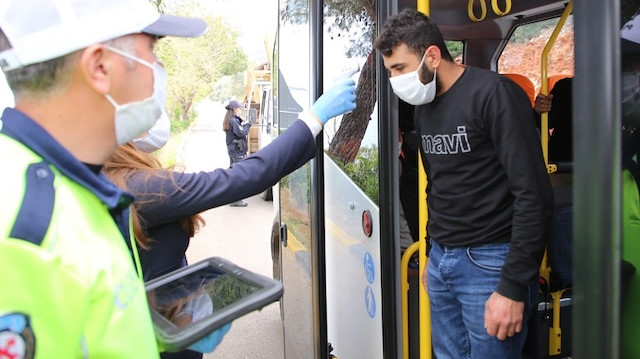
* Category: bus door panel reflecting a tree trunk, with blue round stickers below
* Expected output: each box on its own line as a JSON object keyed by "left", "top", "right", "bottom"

{"left": 323, "top": 1, "right": 382, "bottom": 358}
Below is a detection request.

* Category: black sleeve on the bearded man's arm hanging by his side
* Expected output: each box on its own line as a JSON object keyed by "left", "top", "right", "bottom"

{"left": 484, "top": 79, "right": 553, "bottom": 301}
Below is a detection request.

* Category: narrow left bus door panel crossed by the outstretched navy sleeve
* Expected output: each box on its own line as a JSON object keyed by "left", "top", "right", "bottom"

{"left": 276, "top": 0, "right": 315, "bottom": 358}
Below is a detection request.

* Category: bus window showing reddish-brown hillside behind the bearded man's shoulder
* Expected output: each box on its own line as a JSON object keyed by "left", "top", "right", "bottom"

{"left": 498, "top": 15, "right": 574, "bottom": 94}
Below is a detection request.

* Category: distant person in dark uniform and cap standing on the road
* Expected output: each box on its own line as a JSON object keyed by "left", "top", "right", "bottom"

{"left": 222, "top": 100, "right": 251, "bottom": 207}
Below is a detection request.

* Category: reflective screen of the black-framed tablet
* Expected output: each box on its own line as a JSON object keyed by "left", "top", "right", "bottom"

{"left": 147, "top": 266, "right": 261, "bottom": 328}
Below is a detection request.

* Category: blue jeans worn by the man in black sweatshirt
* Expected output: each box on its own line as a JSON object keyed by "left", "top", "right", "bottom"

{"left": 427, "top": 240, "right": 538, "bottom": 359}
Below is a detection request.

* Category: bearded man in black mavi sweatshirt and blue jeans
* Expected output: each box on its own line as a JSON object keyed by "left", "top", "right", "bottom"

{"left": 374, "top": 9, "right": 553, "bottom": 358}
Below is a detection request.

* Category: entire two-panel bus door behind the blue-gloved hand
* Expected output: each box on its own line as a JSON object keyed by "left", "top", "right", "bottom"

{"left": 276, "top": 0, "right": 400, "bottom": 358}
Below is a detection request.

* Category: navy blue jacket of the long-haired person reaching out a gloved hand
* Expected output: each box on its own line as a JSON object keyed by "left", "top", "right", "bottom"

{"left": 127, "top": 120, "right": 316, "bottom": 280}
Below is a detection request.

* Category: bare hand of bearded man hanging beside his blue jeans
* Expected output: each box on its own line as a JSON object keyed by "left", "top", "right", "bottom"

{"left": 484, "top": 292, "right": 524, "bottom": 340}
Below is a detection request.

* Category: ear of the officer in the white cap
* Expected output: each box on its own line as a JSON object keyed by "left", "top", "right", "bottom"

{"left": 78, "top": 44, "right": 115, "bottom": 95}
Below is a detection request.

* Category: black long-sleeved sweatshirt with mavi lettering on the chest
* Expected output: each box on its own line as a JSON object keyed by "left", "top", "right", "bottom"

{"left": 414, "top": 67, "right": 553, "bottom": 301}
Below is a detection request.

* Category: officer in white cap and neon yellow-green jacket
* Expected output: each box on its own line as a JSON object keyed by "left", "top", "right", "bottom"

{"left": 0, "top": 0, "right": 207, "bottom": 359}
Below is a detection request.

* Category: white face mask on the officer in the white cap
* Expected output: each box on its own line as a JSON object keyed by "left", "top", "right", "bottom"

{"left": 105, "top": 45, "right": 167, "bottom": 145}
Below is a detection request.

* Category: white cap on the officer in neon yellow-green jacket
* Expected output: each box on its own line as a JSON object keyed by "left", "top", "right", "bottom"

{"left": 0, "top": 0, "right": 207, "bottom": 72}
